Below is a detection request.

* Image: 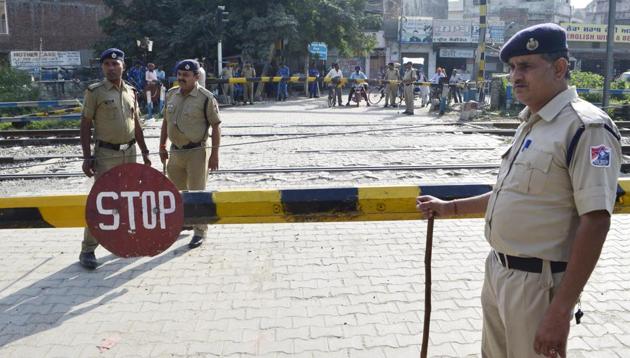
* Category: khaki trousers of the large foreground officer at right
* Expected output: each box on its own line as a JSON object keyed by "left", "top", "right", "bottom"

{"left": 481, "top": 251, "right": 570, "bottom": 358}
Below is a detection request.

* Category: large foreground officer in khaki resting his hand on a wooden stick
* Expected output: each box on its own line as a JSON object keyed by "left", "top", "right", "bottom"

{"left": 417, "top": 24, "right": 622, "bottom": 358}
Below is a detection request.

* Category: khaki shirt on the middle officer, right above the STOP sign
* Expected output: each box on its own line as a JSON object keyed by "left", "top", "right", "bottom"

{"left": 164, "top": 83, "right": 221, "bottom": 148}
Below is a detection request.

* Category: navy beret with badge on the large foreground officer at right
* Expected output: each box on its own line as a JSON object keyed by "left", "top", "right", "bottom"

{"left": 499, "top": 23, "right": 569, "bottom": 62}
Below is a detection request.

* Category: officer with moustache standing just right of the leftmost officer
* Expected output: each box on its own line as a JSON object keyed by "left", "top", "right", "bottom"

{"left": 160, "top": 60, "right": 221, "bottom": 249}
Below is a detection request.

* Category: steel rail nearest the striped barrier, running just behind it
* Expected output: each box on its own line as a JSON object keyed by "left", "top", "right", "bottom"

{"left": 0, "top": 163, "right": 630, "bottom": 181}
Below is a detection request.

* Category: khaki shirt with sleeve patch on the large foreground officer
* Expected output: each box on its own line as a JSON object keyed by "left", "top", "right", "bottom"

{"left": 485, "top": 87, "right": 622, "bottom": 262}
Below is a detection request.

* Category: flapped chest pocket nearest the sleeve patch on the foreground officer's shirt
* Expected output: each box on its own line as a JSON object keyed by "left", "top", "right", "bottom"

{"left": 510, "top": 148, "right": 553, "bottom": 194}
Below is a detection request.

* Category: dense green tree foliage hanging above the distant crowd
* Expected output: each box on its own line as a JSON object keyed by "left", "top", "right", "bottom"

{"left": 96, "top": 0, "right": 382, "bottom": 63}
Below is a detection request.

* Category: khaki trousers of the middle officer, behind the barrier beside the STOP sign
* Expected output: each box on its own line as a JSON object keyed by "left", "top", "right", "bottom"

{"left": 166, "top": 143, "right": 210, "bottom": 237}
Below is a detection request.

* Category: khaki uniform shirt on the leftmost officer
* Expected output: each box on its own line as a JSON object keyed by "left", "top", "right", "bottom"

{"left": 82, "top": 80, "right": 139, "bottom": 144}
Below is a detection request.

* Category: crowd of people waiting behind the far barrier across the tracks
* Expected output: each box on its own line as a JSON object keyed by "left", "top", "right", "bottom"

{"left": 124, "top": 55, "right": 470, "bottom": 118}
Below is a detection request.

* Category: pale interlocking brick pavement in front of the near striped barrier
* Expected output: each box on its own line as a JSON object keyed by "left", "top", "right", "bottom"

{"left": 0, "top": 215, "right": 630, "bottom": 358}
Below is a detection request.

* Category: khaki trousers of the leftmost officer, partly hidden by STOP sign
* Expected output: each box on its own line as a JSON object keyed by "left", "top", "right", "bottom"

{"left": 81, "top": 145, "right": 136, "bottom": 253}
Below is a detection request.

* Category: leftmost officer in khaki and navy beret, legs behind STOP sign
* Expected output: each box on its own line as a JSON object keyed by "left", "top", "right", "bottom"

{"left": 79, "top": 48, "right": 151, "bottom": 270}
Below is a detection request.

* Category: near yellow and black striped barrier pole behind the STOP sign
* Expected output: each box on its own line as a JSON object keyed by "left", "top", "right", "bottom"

{"left": 0, "top": 179, "right": 630, "bottom": 229}
